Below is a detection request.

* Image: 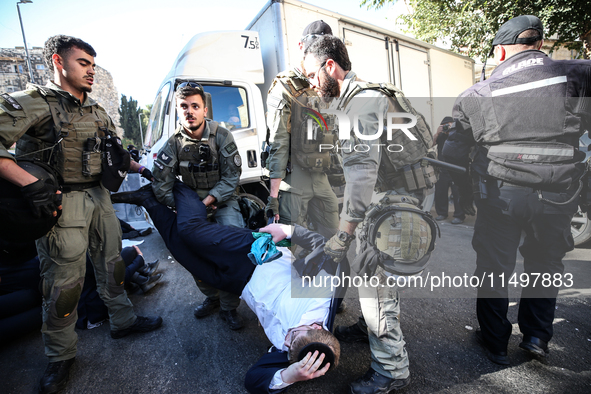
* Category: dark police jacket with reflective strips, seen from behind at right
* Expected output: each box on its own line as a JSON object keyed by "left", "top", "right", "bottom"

{"left": 443, "top": 50, "right": 591, "bottom": 190}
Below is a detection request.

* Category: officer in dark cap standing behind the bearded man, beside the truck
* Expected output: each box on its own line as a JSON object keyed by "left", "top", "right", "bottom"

{"left": 266, "top": 21, "right": 339, "bottom": 238}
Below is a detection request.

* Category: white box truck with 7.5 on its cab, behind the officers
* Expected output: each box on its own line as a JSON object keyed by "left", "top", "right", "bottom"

{"left": 142, "top": 0, "right": 474, "bottom": 201}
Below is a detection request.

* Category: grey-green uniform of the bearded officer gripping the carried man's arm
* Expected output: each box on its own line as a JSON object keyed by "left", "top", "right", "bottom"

{"left": 335, "top": 71, "right": 438, "bottom": 379}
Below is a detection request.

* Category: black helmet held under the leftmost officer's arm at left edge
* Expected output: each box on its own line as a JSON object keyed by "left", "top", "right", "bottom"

{"left": 0, "top": 160, "right": 62, "bottom": 242}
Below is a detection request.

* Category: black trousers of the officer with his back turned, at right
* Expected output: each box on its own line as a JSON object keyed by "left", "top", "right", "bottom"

{"left": 472, "top": 185, "right": 578, "bottom": 351}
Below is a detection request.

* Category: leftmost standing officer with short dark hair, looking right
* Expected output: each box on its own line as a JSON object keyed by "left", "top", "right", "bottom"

{"left": 0, "top": 35, "right": 162, "bottom": 393}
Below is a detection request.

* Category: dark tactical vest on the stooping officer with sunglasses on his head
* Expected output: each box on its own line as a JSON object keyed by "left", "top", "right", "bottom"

{"left": 176, "top": 121, "right": 220, "bottom": 190}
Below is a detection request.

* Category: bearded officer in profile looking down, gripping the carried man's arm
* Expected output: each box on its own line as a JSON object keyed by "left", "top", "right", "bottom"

{"left": 304, "top": 36, "right": 434, "bottom": 393}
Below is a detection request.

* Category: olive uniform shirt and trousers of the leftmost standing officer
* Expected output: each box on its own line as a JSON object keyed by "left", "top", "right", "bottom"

{"left": 0, "top": 82, "right": 137, "bottom": 362}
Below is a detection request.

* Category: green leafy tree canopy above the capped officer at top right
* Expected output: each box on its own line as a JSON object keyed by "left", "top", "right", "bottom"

{"left": 361, "top": 0, "right": 591, "bottom": 60}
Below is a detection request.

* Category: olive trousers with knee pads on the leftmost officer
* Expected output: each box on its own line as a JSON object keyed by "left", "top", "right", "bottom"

{"left": 36, "top": 186, "right": 137, "bottom": 362}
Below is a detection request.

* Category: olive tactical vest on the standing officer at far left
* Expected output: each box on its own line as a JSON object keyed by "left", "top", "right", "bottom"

{"left": 16, "top": 84, "right": 109, "bottom": 185}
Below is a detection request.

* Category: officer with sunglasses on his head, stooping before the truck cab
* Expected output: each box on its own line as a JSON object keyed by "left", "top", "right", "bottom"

{"left": 152, "top": 82, "right": 245, "bottom": 330}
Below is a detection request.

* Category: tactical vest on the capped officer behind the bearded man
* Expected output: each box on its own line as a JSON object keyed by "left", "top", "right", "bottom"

{"left": 271, "top": 72, "right": 337, "bottom": 172}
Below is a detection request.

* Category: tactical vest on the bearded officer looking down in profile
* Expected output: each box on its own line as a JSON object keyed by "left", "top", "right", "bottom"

{"left": 340, "top": 82, "right": 437, "bottom": 192}
